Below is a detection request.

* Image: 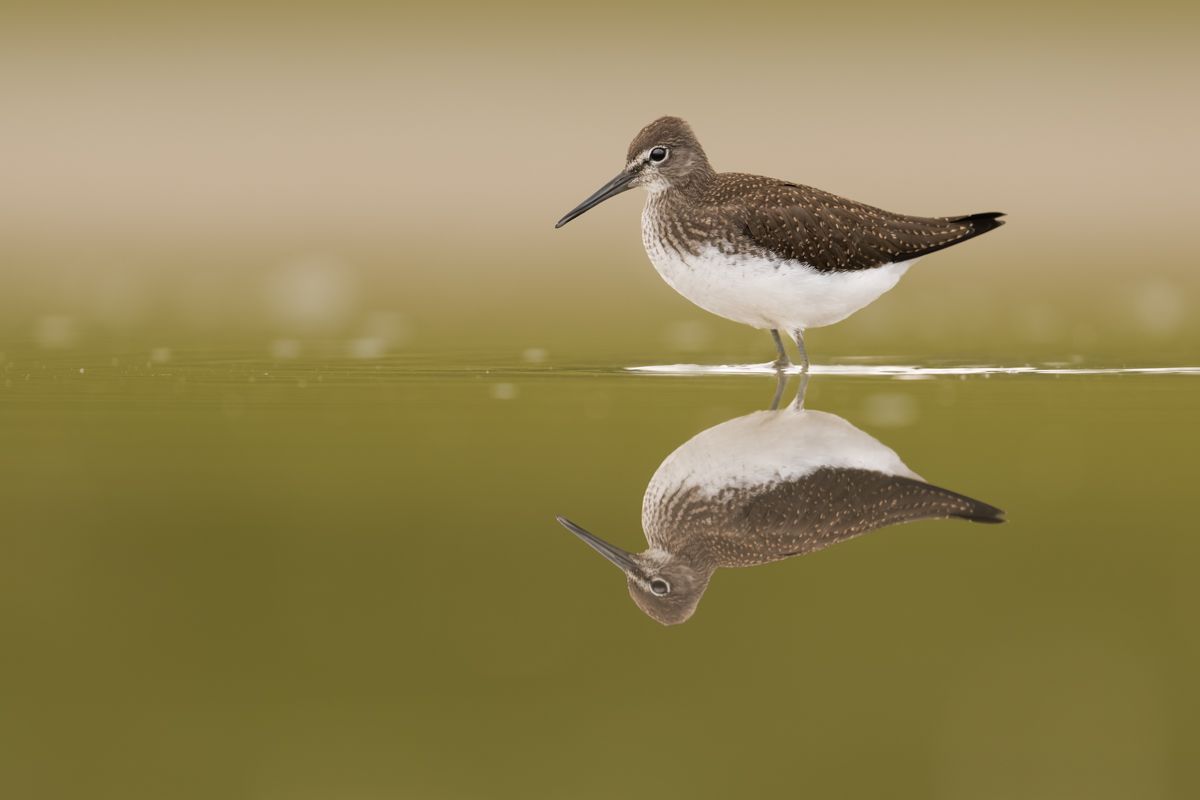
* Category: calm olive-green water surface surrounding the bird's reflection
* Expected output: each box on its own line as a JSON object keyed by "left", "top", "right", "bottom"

{"left": 0, "top": 350, "right": 1200, "bottom": 798}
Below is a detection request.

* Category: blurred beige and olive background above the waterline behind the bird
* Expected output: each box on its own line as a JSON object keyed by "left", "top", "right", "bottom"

{"left": 0, "top": 2, "right": 1200, "bottom": 361}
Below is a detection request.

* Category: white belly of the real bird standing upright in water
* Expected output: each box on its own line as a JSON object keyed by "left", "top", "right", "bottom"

{"left": 642, "top": 211, "right": 917, "bottom": 331}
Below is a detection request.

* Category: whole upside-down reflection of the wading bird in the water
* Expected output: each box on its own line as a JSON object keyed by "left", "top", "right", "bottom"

{"left": 558, "top": 380, "right": 1004, "bottom": 625}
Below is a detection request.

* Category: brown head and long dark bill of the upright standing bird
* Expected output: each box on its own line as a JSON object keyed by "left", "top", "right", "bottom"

{"left": 554, "top": 116, "right": 713, "bottom": 228}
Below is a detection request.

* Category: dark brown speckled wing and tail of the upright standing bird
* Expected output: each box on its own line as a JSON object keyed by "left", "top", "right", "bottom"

{"left": 708, "top": 174, "right": 1003, "bottom": 272}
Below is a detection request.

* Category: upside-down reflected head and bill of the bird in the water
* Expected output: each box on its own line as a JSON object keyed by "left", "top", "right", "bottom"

{"left": 558, "top": 517, "right": 713, "bottom": 625}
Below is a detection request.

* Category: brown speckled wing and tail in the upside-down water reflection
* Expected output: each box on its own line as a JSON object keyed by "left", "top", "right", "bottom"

{"left": 664, "top": 468, "right": 1004, "bottom": 566}
